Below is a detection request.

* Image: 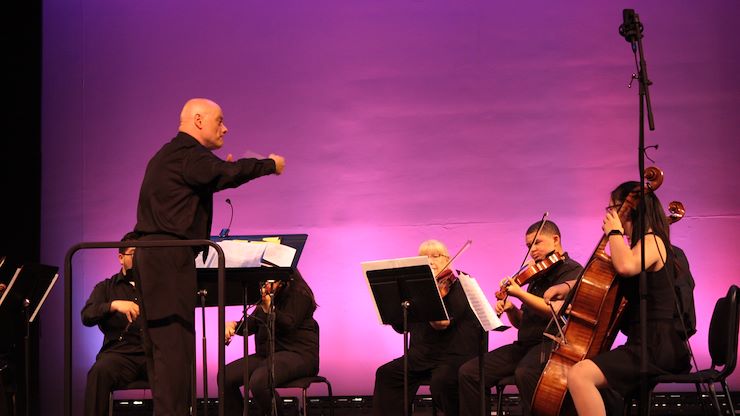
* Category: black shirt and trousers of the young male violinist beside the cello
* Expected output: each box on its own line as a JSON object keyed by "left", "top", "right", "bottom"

{"left": 459, "top": 254, "right": 583, "bottom": 415}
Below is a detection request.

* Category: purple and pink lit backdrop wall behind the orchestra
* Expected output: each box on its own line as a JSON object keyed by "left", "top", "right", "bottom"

{"left": 42, "top": 0, "right": 740, "bottom": 414}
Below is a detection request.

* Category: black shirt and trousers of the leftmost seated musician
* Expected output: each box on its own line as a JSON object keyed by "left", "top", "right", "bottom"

{"left": 81, "top": 271, "right": 147, "bottom": 416}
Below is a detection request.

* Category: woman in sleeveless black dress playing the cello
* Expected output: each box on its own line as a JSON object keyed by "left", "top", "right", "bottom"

{"left": 548, "top": 182, "right": 690, "bottom": 416}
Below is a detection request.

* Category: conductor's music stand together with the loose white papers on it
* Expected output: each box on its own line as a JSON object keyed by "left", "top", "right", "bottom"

{"left": 196, "top": 234, "right": 308, "bottom": 414}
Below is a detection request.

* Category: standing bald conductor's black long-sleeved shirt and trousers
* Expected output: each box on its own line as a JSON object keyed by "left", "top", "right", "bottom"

{"left": 134, "top": 132, "right": 275, "bottom": 416}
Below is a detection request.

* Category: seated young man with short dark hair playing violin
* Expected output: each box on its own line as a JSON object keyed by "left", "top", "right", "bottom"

{"left": 460, "top": 220, "right": 583, "bottom": 415}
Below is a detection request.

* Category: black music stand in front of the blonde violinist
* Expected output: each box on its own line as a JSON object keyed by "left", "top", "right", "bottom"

{"left": 363, "top": 256, "right": 450, "bottom": 415}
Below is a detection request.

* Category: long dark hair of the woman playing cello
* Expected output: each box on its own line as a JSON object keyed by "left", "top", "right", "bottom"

{"left": 611, "top": 181, "right": 671, "bottom": 250}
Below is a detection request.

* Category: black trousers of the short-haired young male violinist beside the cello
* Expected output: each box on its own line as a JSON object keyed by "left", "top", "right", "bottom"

{"left": 459, "top": 341, "right": 552, "bottom": 416}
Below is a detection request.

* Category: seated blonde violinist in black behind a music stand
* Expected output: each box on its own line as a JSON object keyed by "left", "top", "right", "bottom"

{"left": 373, "top": 240, "right": 481, "bottom": 416}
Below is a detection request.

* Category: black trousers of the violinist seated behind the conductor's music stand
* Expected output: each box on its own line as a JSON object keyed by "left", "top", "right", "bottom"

{"left": 218, "top": 351, "right": 319, "bottom": 416}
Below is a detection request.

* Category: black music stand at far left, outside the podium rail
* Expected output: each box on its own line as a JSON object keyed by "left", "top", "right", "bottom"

{"left": 0, "top": 263, "right": 59, "bottom": 414}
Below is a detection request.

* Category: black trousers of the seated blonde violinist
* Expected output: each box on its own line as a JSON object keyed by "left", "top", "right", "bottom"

{"left": 373, "top": 355, "right": 462, "bottom": 416}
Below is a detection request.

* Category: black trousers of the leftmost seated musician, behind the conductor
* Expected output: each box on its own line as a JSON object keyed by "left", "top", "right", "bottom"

{"left": 85, "top": 352, "right": 147, "bottom": 416}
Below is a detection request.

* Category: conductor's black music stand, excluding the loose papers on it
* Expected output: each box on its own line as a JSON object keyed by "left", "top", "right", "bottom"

{"left": 197, "top": 234, "right": 308, "bottom": 415}
